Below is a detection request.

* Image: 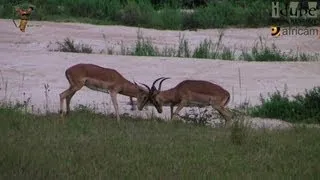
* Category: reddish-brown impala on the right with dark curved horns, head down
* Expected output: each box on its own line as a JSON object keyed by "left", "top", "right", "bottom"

{"left": 138, "top": 77, "right": 231, "bottom": 126}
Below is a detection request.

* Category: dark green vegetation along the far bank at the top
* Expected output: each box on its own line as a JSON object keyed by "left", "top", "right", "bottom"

{"left": 0, "top": 0, "right": 320, "bottom": 29}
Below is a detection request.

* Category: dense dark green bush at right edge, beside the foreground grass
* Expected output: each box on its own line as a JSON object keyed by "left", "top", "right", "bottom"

{"left": 250, "top": 86, "right": 320, "bottom": 123}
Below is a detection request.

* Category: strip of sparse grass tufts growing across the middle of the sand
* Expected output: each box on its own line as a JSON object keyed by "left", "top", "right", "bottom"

{"left": 48, "top": 31, "right": 319, "bottom": 61}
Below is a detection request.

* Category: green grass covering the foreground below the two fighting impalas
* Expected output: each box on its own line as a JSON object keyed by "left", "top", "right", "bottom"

{"left": 0, "top": 107, "right": 320, "bottom": 179}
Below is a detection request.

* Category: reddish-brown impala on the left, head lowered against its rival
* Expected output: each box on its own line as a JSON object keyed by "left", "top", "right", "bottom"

{"left": 60, "top": 64, "right": 148, "bottom": 122}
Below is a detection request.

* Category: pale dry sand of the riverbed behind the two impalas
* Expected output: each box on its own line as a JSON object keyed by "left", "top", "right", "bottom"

{"left": 0, "top": 20, "right": 320, "bottom": 127}
